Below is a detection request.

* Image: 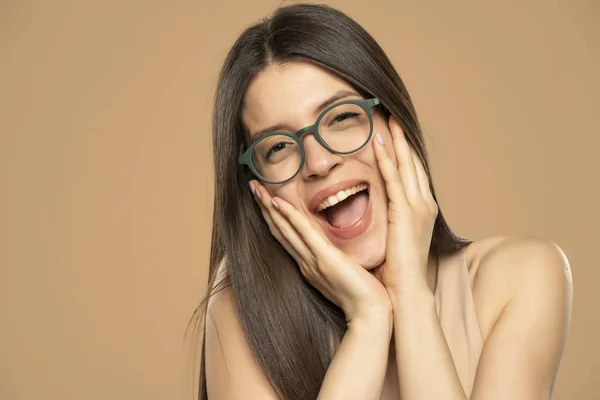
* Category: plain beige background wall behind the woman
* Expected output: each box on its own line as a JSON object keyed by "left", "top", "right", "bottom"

{"left": 0, "top": 0, "right": 600, "bottom": 400}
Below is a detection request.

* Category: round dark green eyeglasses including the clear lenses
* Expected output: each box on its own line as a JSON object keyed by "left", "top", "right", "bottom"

{"left": 238, "top": 98, "right": 380, "bottom": 184}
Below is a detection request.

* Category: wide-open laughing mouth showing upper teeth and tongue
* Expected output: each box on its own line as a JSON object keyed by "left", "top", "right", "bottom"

{"left": 315, "top": 182, "right": 369, "bottom": 230}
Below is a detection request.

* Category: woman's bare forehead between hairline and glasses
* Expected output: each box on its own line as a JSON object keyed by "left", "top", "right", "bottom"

{"left": 242, "top": 62, "right": 353, "bottom": 132}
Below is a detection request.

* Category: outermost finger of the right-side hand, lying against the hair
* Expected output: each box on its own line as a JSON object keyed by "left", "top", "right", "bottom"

{"left": 389, "top": 116, "right": 422, "bottom": 204}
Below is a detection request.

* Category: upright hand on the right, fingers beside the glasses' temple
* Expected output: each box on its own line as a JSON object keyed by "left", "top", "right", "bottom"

{"left": 373, "top": 116, "right": 438, "bottom": 294}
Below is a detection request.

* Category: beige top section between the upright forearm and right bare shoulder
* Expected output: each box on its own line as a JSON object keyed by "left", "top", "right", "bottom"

{"left": 435, "top": 248, "right": 483, "bottom": 397}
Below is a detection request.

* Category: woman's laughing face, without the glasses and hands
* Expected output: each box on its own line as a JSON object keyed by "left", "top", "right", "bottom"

{"left": 242, "top": 62, "right": 394, "bottom": 269}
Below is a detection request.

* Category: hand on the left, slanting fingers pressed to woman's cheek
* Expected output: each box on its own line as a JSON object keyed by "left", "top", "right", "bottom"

{"left": 250, "top": 180, "right": 392, "bottom": 324}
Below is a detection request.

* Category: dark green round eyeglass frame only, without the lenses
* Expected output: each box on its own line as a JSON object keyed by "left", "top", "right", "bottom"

{"left": 238, "top": 97, "right": 380, "bottom": 185}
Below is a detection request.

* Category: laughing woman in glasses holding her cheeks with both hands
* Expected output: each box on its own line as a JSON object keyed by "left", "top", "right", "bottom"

{"left": 200, "top": 5, "right": 572, "bottom": 400}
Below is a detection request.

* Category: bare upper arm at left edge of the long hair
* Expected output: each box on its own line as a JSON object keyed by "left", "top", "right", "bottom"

{"left": 204, "top": 263, "right": 275, "bottom": 400}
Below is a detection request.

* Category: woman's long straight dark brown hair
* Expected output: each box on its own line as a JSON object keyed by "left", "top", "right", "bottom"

{"left": 193, "top": 4, "right": 470, "bottom": 400}
